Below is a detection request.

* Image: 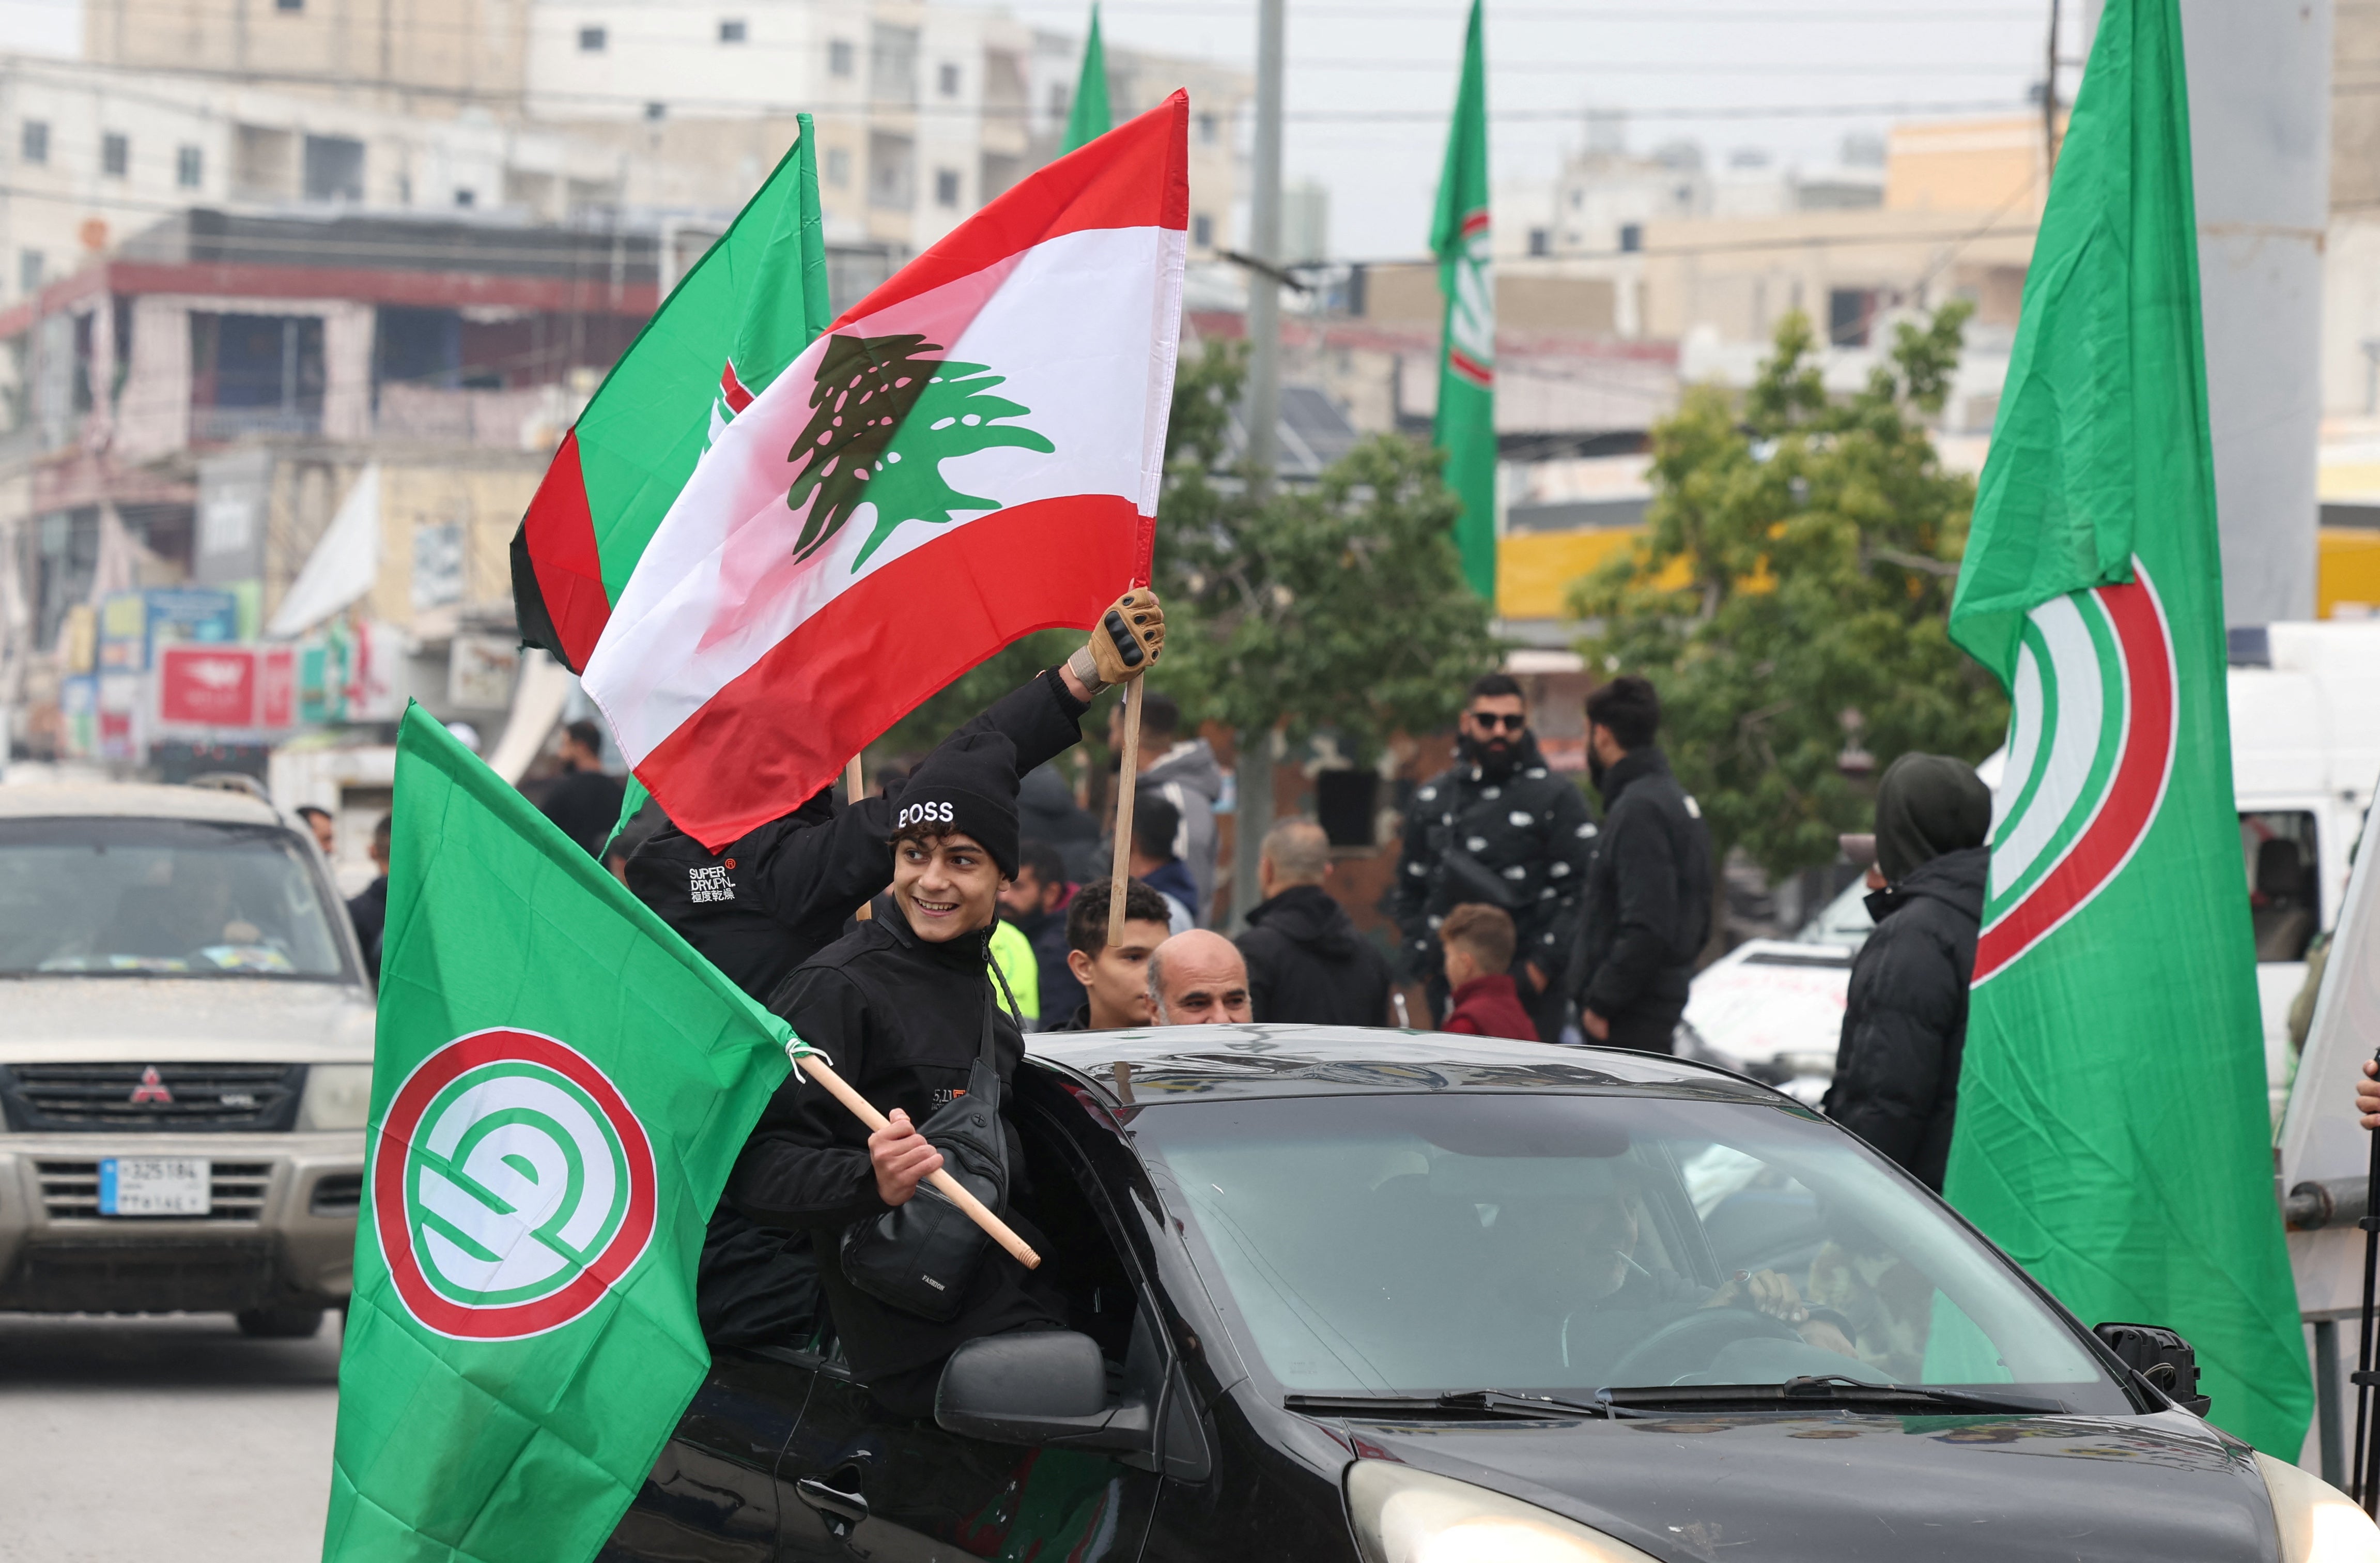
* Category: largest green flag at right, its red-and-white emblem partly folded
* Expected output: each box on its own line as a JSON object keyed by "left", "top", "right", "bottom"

{"left": 1947, "top": 0, "right": 2311, "bottom": 1461}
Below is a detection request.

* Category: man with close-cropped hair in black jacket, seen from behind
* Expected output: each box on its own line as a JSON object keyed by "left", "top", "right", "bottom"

{"left": 1240, "top": 818, "right": 1393, "bottom": 1025}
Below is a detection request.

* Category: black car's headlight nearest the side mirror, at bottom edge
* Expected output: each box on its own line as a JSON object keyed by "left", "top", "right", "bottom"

{"left": 1347, "top": 1461, "right": 1657, "bottom": 1563}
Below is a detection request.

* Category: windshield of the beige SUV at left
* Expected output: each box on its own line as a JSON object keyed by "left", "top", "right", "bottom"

{"left": 0, "top": 816, "right": 347, "bottom": 978}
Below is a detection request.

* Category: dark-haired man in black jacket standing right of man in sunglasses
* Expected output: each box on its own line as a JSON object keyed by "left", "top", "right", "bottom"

{"left": 1571, "top": 678, "right": 1711, "bottom": 1054}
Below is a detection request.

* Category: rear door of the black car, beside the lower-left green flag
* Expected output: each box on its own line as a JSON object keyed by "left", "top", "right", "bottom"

{"left": 597, "top": 1346, "right": 814, "bottom": 1563}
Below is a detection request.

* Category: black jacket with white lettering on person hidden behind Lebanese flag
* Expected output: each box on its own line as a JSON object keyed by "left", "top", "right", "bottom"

{"left": 628, "top": 671, "right": 1088, "bottom": 999}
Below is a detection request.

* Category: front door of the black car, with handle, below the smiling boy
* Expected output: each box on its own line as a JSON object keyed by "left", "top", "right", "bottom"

{"left": 778, "top": 1113, "right": 1166, "bottom": 1563}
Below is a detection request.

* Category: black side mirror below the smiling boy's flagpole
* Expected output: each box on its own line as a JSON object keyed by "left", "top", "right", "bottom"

{"left": 933, "top": 1330, "right": 1154, "bottom": 1449}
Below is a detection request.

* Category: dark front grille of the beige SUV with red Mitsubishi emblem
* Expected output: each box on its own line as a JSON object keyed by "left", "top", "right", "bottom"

{"left": 0, "top": 1063, "right": 305, "bottom": 1135}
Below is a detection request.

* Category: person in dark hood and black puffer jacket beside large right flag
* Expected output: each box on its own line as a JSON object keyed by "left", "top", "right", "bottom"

{"left": 1823, "top": 754, "right": 1992, "bottom": 1192}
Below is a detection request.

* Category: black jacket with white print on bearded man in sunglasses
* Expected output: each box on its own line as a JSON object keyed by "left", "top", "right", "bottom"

{"left": 1390, "top": 735, "right": 1595, "bottom": 983}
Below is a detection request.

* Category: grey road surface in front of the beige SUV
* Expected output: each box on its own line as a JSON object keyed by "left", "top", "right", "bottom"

{"left": 0, "top": 1313, "right": 338, "bottom": 1563}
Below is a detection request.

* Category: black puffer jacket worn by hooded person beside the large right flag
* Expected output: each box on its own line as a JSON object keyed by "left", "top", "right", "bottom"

{"left": 1823, "top": 847, "right": 1990, "bottom": 1192}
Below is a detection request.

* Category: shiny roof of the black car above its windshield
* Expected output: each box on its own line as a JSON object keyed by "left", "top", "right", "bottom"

{"left": 1026, "top": 1025, "right": 1799, "bottom": 1106}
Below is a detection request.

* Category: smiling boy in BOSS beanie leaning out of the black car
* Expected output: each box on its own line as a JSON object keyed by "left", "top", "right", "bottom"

{"left": 728, "top": 733, "right": 1066, "bottom": 1416}
